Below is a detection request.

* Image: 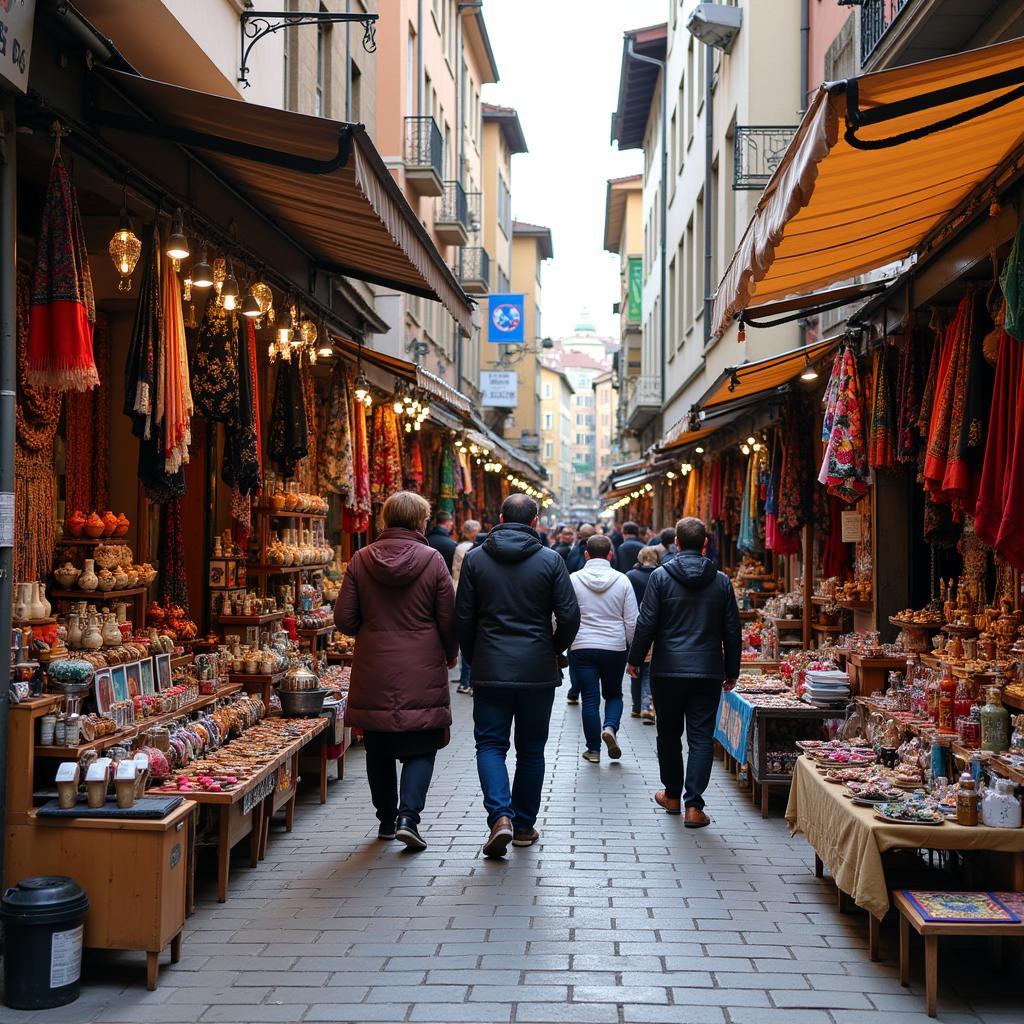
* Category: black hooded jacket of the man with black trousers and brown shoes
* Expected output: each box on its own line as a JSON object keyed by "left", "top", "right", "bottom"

{"left": 629, "top": 551, "right": 741, "bottom": 680}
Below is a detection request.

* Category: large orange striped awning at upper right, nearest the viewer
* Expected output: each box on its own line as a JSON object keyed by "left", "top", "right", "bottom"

{"left": 713, "top": 39, "right": 1024, "bottom": 338}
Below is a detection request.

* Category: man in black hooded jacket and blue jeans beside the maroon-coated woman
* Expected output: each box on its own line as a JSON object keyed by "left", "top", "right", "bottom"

{"left": 456, "top": 494, "right": 580, "bottom": 857}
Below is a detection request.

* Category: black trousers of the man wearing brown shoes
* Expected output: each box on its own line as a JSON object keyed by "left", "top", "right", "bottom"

{"left": 651, "top": 676, "right": 722, "bottom": 810}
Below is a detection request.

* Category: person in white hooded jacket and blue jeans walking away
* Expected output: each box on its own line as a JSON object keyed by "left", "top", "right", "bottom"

{"left": 569, "top": 534, "right": 637, "bottom": 764}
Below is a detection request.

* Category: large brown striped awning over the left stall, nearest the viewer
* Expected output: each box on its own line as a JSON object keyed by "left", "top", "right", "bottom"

{"left": 96, "top": 68, "right": 472, "bottom": 336}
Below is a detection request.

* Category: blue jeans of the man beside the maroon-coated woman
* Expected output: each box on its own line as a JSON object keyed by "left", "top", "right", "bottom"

{"left": 473, "top": 686, "right": 555, "bottom": 828}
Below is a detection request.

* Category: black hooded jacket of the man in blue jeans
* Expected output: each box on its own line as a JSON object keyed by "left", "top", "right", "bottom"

{"left": 456, "top": 522, "right": 580, "bottom": 689}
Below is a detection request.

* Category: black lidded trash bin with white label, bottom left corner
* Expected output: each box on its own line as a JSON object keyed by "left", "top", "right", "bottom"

{"left": 0, "top": 874, "right": 89, "bottom": 1010}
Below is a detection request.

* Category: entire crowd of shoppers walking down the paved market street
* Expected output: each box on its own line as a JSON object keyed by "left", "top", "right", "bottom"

{"left": 335, "top": 492, "right": 740, "bottom": 857}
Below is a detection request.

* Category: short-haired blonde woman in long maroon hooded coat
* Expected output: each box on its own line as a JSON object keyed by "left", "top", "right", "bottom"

{"left": 334, "top": 490, "right": 459, "bottom": 850}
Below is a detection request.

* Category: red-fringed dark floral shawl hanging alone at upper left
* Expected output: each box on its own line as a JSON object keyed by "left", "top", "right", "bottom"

{"left": 28, "top": 149, "right": 99, "bottom": 391}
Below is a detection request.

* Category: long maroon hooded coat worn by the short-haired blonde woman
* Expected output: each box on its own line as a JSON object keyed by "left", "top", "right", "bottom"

{"left": 334, "top": 527, "right": 459, "bottom": 732}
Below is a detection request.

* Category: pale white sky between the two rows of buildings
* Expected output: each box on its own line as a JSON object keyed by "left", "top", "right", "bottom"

{"left": 483, "top": 0, "right": 668, "bottom": 338}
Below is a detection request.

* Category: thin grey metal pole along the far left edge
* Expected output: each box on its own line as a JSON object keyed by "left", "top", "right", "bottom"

{"left": 0, "top": 97, "right": 17, "bottom": 880}
